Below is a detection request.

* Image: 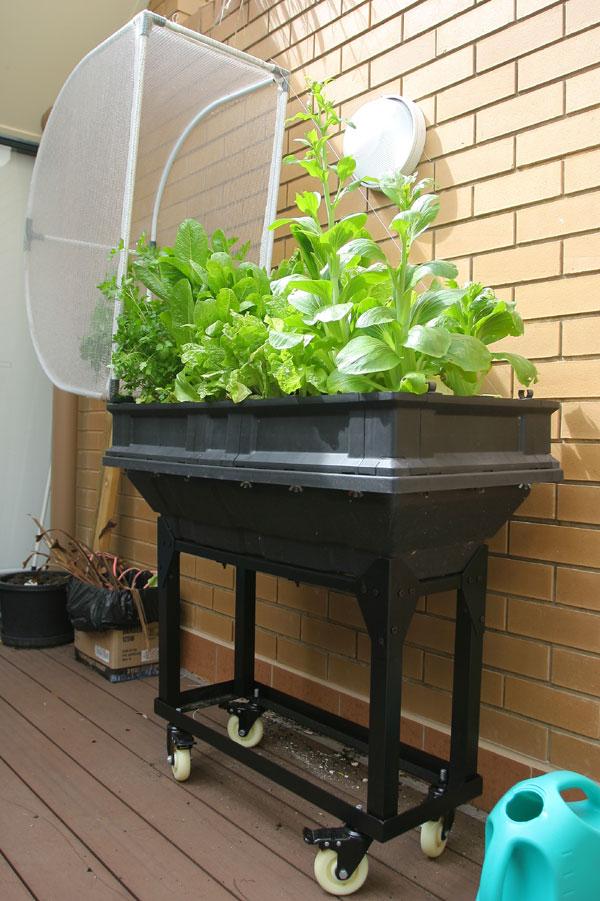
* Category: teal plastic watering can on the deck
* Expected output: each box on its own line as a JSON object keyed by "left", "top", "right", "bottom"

{"left": 477, "top": 771, "right": 600, "bottom": 901}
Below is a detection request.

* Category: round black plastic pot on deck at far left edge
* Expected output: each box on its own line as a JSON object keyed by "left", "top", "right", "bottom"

{"left": 0, "top": 572, "right": 73, "bottom": 648}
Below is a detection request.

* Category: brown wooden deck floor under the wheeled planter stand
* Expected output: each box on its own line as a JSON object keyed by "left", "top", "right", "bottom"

{"left": 0, "top": 646, "right": 483, "bottom": 901}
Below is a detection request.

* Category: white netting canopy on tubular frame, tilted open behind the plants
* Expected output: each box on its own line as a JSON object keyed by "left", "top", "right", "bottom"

{"left": 25, "top": 11, "right": 287, "bottom": 397}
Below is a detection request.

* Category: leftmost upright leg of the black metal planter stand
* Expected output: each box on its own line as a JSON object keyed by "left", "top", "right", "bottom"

{"left": 158, "top": 516, "right": 181, "bottom": 707}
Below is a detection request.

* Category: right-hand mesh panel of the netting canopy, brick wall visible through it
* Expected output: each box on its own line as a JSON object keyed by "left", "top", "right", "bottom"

{"left": 132, "top": 28, "right": 277, "bottom": 262}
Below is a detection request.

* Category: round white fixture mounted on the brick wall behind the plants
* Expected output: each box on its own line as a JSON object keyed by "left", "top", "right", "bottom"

{"left": 344, "top": 95, "right": 425, "bottom": 181}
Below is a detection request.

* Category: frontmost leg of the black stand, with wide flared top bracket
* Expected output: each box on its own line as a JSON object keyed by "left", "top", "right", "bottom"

{"left": 359, "top": 560, "right": 419, "bottom": 819}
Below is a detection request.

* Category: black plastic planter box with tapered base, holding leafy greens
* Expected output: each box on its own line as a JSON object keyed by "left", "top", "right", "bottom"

{"left": 104, "top": 394, "right": 562, "bottom": 578}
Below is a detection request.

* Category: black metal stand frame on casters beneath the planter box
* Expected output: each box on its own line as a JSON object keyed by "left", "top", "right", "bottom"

{"left": 155, "top": 517, "right": 487, "bottom": 879}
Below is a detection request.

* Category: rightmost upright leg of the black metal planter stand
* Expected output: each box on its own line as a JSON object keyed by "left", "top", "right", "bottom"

{"left": 448, "top": 546, "right": 487, "bottom": 787}
